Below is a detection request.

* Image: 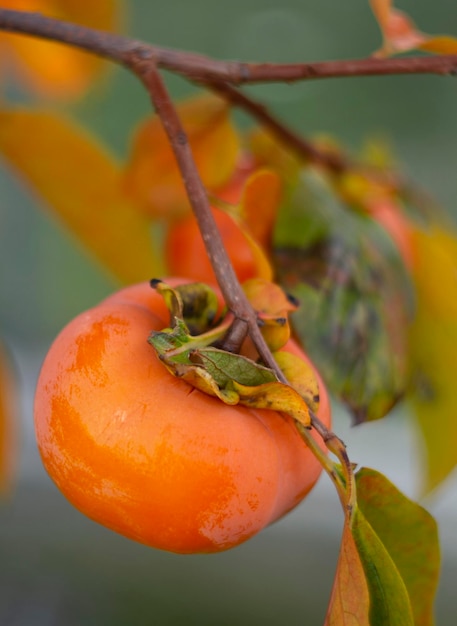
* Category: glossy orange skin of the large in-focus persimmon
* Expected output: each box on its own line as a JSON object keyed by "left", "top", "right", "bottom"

{"left": 34, "top": 279, "right": 330, "bottom": 553}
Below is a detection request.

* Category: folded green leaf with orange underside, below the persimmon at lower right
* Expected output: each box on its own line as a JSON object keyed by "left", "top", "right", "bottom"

{"left": 326, "top": 468, "right": 440, "bottom": 626}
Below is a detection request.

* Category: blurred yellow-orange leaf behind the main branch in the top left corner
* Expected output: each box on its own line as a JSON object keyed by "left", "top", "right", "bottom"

{"left": 0, "top": 0, "right": 120, "bottom": 98}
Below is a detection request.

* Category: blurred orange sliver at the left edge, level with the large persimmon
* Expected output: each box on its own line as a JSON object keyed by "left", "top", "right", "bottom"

{"left": 0, "top": 345, "right": 17, "bottom": 496}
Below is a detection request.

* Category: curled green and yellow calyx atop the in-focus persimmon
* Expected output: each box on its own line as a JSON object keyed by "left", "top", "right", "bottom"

{"left": 148, "top": 281, "right": 311, "bottom": 428}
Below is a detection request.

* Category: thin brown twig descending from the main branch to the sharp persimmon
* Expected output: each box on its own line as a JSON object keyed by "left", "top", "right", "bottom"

{"left": 138, "top": 65, "right": 284, "bottom": 382}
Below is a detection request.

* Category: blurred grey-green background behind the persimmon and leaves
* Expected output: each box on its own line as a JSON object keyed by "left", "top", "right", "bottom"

{"left": 0, "top": 0, "right": 457, "bottom": 626}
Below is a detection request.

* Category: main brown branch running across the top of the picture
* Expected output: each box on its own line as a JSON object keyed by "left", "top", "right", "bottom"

{"left": 0, "top": 8, "right": 457, "bottom": 85}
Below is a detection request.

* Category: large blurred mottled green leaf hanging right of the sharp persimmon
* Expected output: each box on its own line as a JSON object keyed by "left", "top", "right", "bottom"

{"left": 275, "top": 168, "right": 412, "bottom": 423}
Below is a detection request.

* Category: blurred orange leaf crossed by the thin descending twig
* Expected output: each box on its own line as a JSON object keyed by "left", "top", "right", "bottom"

{"left": 124, "top": 95, "right": 239, "bottom": 219}
